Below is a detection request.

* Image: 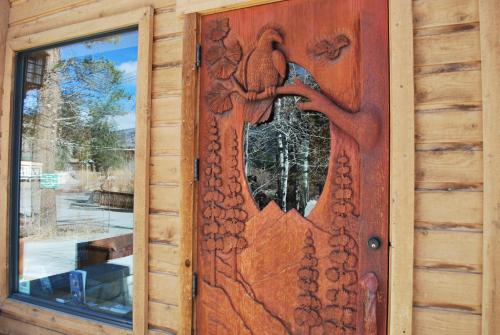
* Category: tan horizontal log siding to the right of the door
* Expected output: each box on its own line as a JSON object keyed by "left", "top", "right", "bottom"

{"left": 413, "top": 0, "right": 483, "bottom": 335}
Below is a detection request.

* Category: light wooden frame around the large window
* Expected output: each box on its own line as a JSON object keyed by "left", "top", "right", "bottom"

{"left": 0, "top": 7, "right": 154, "bottom": 335}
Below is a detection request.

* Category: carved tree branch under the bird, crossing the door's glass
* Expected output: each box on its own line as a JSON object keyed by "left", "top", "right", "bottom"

{"left": 227, "top": 76, "right": 380, "bottom": 150}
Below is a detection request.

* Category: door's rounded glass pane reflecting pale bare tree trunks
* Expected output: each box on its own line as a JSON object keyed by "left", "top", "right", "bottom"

{"left": 245, "top": 63, "right": 330, "bottom": 216}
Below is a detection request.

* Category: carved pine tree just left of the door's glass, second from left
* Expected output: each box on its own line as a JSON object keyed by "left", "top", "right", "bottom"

{"left": 219, "top": 129, "right": 248, "bottom": 280}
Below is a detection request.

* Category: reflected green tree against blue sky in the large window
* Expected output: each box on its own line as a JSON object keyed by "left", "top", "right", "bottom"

{"left": 54, "top": 57, "right": 131, "bottom": 178}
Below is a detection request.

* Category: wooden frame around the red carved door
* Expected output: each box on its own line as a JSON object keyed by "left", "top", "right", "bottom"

{"left": 178, "top": 0, "right": 415, "bottom": 335}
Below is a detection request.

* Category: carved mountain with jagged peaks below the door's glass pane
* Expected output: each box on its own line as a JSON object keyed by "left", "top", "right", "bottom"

{"left": 238, "top": 202, "right": 330, "bottom": 335}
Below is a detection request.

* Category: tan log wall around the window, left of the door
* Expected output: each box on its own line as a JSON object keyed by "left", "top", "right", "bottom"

{"left": 0, "top": 0, "right": 183, "bottom": 335}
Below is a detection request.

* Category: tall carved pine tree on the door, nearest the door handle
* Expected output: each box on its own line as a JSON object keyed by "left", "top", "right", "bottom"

{"left": 322, "top": 152, "right": 358, "bottom": 335}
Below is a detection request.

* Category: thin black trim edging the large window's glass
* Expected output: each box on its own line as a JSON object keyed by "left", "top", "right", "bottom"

{"left": 8, "top": 25, "right": 139, "bottom": 329}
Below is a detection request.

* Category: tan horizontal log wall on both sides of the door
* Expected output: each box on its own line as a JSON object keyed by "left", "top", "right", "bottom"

{"left": 0, "top": 0, "right": 496, "bottom": 335}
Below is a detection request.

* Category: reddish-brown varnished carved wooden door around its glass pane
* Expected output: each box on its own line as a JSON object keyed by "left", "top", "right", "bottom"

{"left": 196, "top": 0, "right": 389, "bottom": 334}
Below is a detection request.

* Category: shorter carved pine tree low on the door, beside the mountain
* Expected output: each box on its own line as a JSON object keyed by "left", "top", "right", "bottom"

{"left": 294, "top": 229, "right": 322, "bottom": 335}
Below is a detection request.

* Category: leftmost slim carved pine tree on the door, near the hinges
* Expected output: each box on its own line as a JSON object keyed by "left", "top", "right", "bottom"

{"left": 202, "top": 117, "right": 225, "bottom": 285}
